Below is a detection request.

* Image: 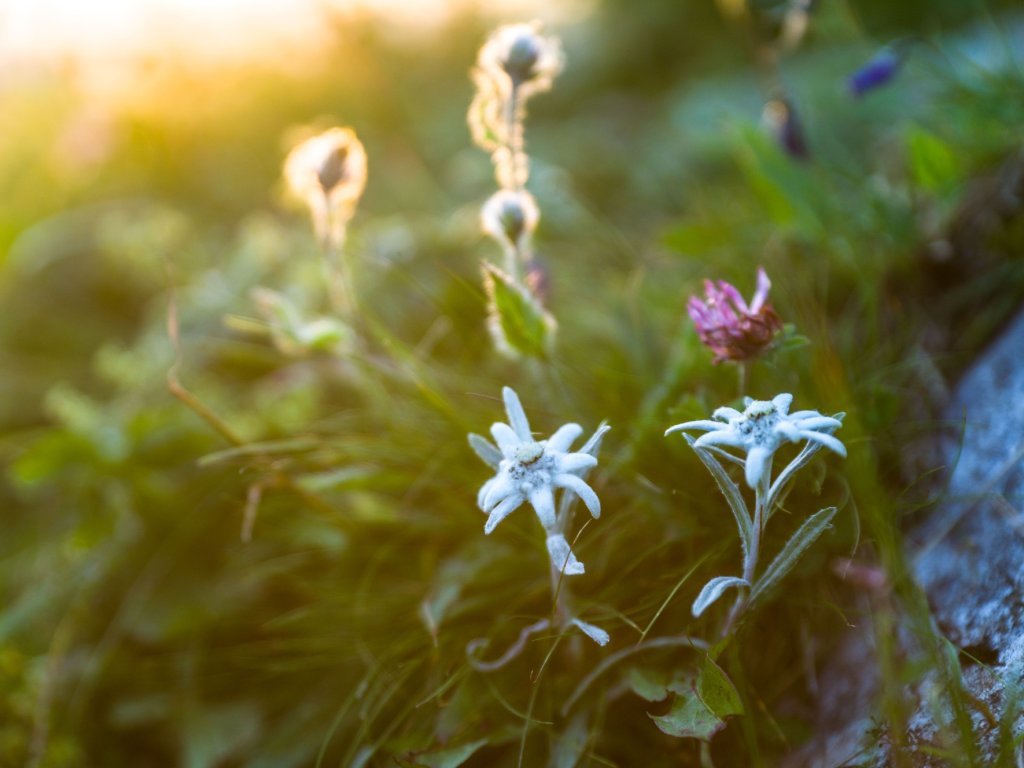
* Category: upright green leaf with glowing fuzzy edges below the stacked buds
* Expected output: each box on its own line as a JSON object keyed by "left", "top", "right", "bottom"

{"left": 483, "top": 262, "right": 556, "bottom": 357}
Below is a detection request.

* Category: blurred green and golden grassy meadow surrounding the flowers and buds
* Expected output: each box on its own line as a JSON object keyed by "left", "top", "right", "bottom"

{"left": 0, "top": 0, "right": 1024, "bottom": 768}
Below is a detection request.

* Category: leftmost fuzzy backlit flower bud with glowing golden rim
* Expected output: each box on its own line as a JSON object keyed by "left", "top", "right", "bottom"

{"left": 285, "top": 128, "right": 367, "bottom": 245}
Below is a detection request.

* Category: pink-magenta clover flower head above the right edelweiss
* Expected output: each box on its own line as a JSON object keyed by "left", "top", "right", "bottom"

{"left": 687, "top": 267, "right": 782, "bottom": 365}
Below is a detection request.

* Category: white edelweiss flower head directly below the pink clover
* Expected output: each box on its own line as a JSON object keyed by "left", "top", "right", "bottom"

{"left": 665, "top": 394, "right": 846, "bottom": 488}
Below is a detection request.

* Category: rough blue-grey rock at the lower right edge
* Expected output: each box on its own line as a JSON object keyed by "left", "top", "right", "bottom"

{"left": 786, "top": 312, "right": 1024, "bottom": 768}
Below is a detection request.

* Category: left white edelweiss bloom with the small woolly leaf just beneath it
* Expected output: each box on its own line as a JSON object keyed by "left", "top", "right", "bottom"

{"left": 476, "top": 387, "right": 601, "bottom": 574}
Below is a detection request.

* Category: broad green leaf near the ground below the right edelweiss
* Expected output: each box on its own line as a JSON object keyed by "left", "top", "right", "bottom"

{"left": 648, "top": 656, "right": 743, "bottom": 741}
